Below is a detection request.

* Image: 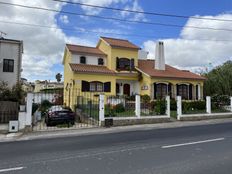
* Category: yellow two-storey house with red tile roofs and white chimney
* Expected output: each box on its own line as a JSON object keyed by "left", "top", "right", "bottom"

{"left": 63, "top": 37, "right": 205, "bottom": 107}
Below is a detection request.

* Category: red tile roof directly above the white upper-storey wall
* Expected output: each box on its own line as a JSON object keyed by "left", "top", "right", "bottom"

{"left": 66, "top": 44, "right": 106, "bottom": 57}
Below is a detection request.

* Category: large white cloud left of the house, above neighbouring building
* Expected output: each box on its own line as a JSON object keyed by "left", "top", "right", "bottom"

{"left": 0, "top": 0, "right": 93, "bottom": 80}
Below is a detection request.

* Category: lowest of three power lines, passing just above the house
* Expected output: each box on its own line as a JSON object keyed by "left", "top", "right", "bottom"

{"left": 0, "top": 20, "right": 232, "bottom": 42}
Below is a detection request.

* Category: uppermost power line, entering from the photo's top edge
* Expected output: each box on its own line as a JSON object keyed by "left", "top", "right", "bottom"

{"left": 53, "top": 0, "right": 232, "bottom": 22}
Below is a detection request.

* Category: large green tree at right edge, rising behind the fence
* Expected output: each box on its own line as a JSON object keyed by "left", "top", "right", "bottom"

{"left": 204, "top": 61, "right": 232, "bottom": 96}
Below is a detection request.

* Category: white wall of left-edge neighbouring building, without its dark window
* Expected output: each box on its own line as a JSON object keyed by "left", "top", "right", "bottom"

{"left": 0, "top": 42, "right": 21, "bottom": 87}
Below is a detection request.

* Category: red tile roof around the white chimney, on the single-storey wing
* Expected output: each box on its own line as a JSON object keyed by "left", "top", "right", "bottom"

{"left": 138, "top": 60, "right": 205, "bottom": 80}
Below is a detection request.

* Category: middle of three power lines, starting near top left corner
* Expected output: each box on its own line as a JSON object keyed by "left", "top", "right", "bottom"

{"left": 0, "top": 2, "right": 232, "bottom": 32}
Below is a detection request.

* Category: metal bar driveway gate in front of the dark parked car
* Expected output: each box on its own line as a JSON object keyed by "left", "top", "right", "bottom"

{"left": 32, "top": 89, "right": 99, "bottom": 131}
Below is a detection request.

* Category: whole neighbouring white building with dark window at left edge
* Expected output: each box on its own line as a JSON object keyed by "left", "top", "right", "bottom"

{"left": 0, "top": 37, "right": 23, "bottom": 87}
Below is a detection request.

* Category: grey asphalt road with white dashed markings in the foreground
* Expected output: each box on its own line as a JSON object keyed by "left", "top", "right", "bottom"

{"left": 0, "top": 123, "right": 232, "bottom": 174}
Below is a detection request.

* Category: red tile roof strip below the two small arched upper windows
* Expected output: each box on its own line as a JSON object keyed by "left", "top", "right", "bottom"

{"left": 69, "top": 63, "right": 115, "bottom": 74}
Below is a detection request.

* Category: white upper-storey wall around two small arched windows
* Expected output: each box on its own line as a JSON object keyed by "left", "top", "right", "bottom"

{"left": 71, "top": 54, "right": 107, "bottom": 65}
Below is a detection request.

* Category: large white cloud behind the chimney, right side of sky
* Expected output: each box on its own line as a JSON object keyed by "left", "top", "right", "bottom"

{"left": 143, "top": 14, "right": 232, "bottom": 71}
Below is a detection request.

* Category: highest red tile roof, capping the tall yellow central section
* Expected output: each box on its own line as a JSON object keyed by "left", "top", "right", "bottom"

{"left": 101, "top": 37, "right": 140, "bottom": 49}
